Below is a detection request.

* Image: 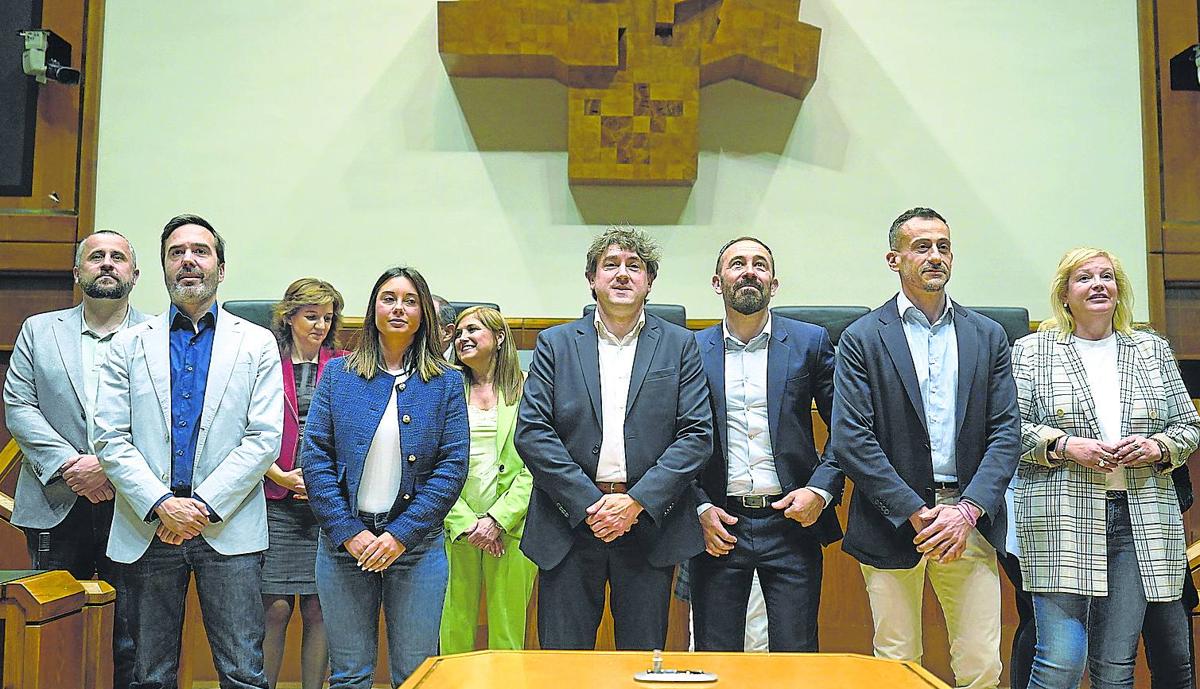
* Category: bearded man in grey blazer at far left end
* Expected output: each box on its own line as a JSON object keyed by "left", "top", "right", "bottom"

{"left": 4, "top": 229, "right": 146, "bottom": 687}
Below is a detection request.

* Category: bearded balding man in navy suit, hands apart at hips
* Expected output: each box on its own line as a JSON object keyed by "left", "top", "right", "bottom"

{"left": 690, "top": 236, "right": 845, "bottom": 652}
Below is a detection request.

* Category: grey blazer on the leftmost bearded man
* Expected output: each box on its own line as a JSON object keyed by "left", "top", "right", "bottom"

{"left": 4, "top": 304, "right": 148, "bottom": 528}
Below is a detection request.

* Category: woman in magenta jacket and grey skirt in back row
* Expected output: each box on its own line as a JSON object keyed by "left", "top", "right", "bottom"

{"left": 263, "top": 277, "right": 346, "bottom": 689}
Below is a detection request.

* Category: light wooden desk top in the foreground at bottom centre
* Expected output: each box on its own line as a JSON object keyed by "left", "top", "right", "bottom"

{"left": 401, "top": 651, "right": 948, "bottom": 689}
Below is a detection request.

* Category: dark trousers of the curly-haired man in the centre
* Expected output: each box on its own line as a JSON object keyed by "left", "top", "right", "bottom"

{"left": 538, "top": 522, "right": 681, "bottom": 651}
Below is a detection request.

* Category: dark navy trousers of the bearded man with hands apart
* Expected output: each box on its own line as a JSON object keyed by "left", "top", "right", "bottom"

{"left": 690, "top": 505, "right": 822, "bottom": 653}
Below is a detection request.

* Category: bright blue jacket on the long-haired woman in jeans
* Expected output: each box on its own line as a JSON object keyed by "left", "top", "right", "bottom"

{"left": 301, "top": 357, "right": 470, "bottom": 550}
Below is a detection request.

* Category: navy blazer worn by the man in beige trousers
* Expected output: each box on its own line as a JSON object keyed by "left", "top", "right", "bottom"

{"left": 830, "top": 298, "right": 1021, "bottom": 569}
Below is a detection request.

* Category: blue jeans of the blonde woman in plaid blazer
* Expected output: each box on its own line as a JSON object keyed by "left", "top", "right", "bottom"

{"left": 1028, "top": 498, "right": 1146, "bottom": 689}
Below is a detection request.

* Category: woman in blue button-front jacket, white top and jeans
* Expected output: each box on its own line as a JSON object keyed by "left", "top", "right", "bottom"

{"left": 302, "top": 268, "right": 469, "bottom": 689}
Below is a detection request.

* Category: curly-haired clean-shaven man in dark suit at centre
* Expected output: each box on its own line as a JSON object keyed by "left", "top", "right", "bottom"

{"left": 515, "top": 228, "right": 713, "bottom": 649}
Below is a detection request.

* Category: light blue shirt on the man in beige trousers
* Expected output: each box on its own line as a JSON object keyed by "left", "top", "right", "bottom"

{"left": 896, "top": 292, "right": 959, "bottom": 481}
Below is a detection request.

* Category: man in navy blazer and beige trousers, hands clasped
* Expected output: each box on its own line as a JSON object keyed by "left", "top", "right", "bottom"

{"left": 830, "top": 208, "right": 1020, "bottom": 689}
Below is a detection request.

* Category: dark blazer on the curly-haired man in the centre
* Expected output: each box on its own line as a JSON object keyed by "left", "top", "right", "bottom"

{"left": 515, "top": 313, "right": 713, "bottom": 569}
